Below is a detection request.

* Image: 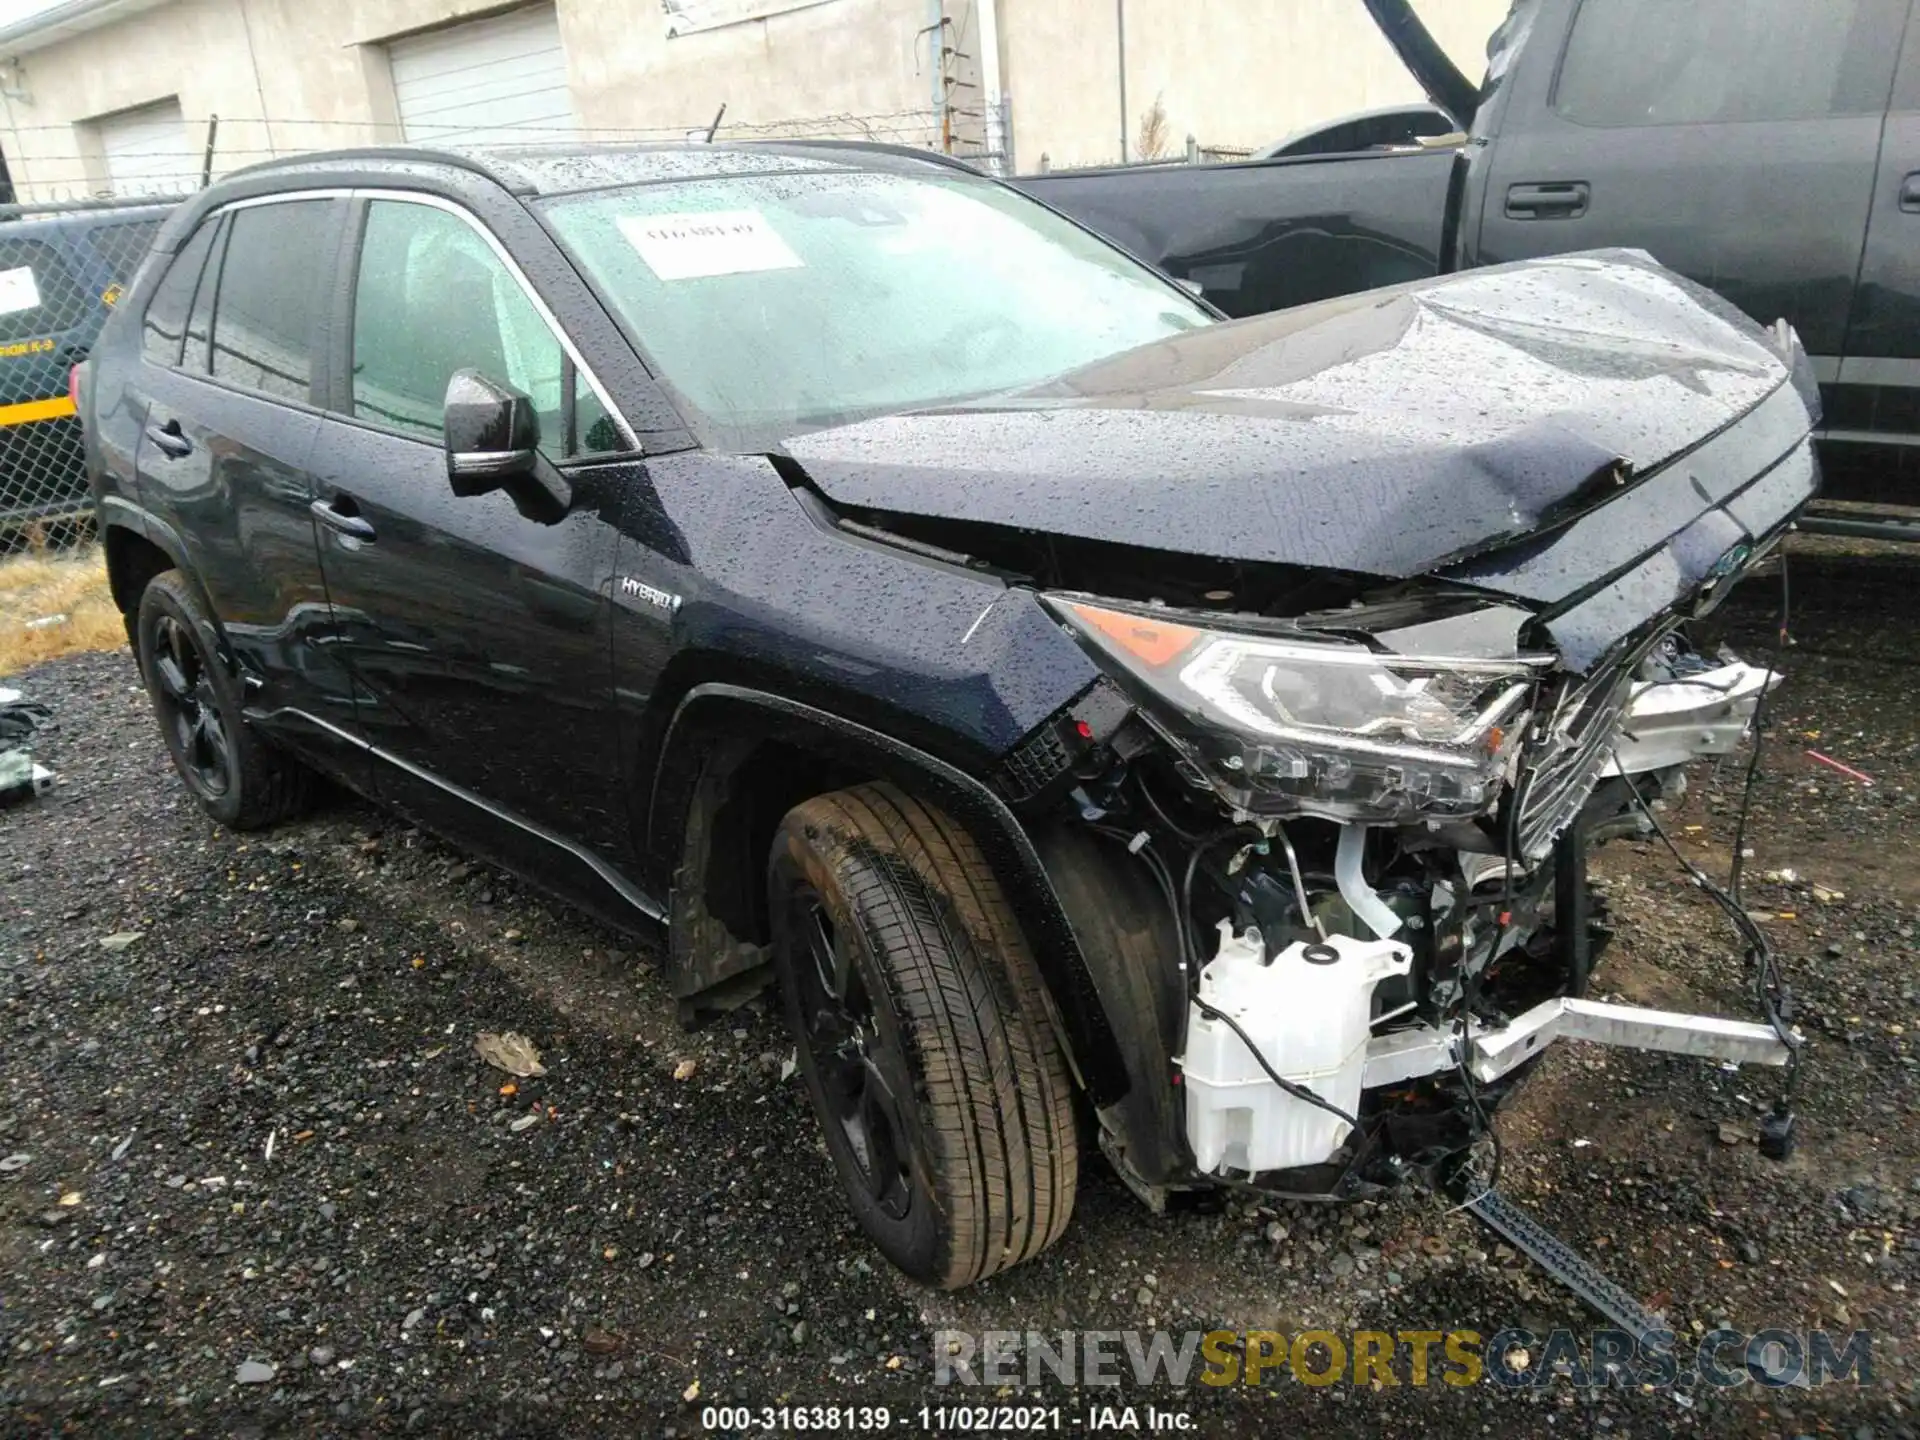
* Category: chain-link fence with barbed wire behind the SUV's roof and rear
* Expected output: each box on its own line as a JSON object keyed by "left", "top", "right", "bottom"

{"left": 0, "top": 106, "right": 1012, "bottom": 553}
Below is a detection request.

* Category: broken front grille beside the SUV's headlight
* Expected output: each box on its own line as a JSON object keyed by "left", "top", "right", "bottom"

{"left": 1515, "top": 624, "right": 1672, "bottom": 862}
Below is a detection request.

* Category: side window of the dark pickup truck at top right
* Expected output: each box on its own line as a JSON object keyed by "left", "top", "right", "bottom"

{"left": 1553, "top": 0, "right": 1907, "bottom": 127}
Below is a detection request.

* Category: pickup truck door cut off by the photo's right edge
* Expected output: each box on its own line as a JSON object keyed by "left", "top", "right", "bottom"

{"left": 1826, "top": 6, "right": 1920, "bottom": 451}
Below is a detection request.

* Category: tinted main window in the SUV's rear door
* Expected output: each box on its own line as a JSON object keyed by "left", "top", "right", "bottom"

{"left": 213, "top": 200, "right": 332, "bottom": 399}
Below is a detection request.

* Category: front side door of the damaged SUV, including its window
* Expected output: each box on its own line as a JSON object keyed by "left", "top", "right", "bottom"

{"left": 313, "top": 198, "right": 634, "bottom": 910}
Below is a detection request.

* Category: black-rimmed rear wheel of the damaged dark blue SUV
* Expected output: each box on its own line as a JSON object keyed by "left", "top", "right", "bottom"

{"left": 134, "top": 570, "right": 311, "bottom": 829}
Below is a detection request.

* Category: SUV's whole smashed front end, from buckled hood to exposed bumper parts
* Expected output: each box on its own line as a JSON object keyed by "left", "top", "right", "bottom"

{"left": 785, "top": 252, "right": 1818, "bottom": 1200}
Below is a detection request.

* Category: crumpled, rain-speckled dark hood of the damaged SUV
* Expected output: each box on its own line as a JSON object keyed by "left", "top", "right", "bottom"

{"left": 785, "top": 252, "right": 1812, "bottom": 599}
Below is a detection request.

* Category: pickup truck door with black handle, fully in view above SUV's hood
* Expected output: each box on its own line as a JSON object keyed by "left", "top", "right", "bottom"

{"left": 1478, "top": 0, "right": 1907, "bottom": 368}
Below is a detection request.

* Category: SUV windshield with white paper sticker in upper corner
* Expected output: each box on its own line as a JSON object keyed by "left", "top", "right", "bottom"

{"left": 545, "top": 171, "right": 1212, "bottom": 449}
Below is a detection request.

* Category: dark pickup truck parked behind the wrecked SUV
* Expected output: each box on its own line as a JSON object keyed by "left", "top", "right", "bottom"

{"left": 1018, "top": 0, "right": 1920, "bottom": 534}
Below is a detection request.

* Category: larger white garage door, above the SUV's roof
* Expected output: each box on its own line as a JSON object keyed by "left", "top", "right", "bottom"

{"left": 388, "top": 6, "right": 574, "bottom": 144}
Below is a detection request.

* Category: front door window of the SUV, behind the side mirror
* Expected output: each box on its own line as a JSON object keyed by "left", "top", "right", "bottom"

{"left": 353, "top": 200, "right": 586, "bottom": 459}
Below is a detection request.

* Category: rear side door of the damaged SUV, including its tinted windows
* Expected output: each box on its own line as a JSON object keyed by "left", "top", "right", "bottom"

{"left": 138, "top": 198, "right": 363, "bottom": 781}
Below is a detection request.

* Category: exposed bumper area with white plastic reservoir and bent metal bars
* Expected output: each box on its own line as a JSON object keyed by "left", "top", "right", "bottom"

{"left": 1102, "top": 637, "right": 1799, "bottom": 1206}
